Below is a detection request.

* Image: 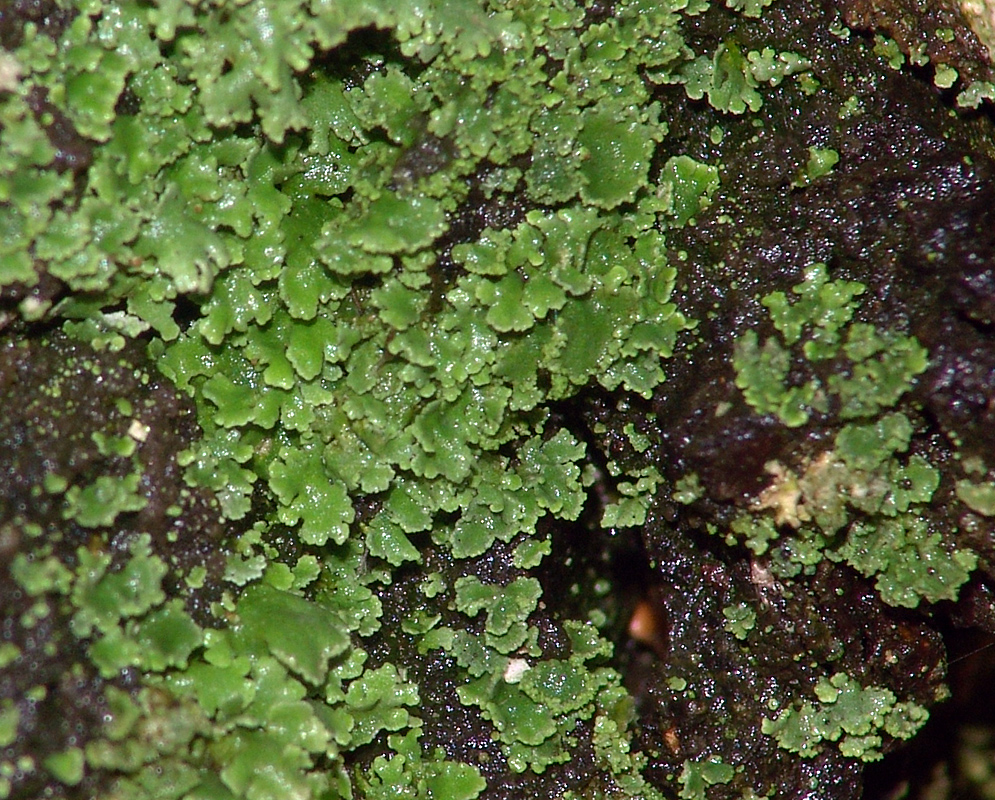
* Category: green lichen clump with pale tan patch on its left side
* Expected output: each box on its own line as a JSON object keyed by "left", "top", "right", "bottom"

{"left": 732, "top": 434, "right": 977, "bottom": 607}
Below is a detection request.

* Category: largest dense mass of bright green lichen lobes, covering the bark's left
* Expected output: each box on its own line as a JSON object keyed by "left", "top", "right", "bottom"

{"left": 0, "top": 1, "right": 716, "bottom": 797}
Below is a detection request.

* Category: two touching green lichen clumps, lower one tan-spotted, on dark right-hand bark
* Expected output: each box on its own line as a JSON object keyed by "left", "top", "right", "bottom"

{"left": 727, "top": 264, "right": 977, "bottom": 607}
